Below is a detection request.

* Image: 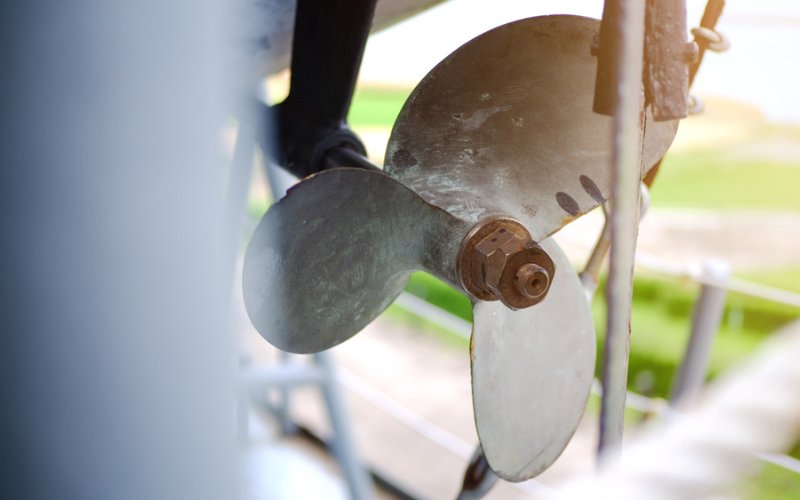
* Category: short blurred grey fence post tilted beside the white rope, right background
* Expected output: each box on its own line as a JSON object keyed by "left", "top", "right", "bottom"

{"left": 670, "top": 260, "right": 731, "bottom": 405}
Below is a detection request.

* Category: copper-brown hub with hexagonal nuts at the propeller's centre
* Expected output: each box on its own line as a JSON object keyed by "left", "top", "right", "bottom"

{"left": 458, "top": 218, "right": 555, "bottom": 309}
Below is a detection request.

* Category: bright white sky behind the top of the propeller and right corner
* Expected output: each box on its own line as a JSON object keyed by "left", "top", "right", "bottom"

{"left": 361, "top": 0, "right": 800, "bottom": 123}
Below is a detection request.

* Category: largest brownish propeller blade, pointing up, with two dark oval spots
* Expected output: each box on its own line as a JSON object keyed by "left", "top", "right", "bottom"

{"left": 385, "top": 16, "right": 677, "bottom": 241}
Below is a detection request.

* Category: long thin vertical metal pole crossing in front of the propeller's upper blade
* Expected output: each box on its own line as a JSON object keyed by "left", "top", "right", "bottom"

{"left": 598, "top": 0, "right": 645, "bottom": 463}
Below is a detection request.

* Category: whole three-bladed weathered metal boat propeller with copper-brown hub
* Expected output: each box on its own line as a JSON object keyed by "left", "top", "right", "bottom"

{"left": 243, "top": 15, "right": 677, "bottom": 481}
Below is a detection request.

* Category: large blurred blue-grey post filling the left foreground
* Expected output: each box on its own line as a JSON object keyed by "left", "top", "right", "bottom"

{"left": 0, "top": 0, "right": 237, "bottom": 500}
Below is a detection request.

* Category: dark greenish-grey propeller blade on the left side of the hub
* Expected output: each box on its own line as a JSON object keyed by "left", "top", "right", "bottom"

{"left": 242, "top": 168, "right": 469, "bottom": 353}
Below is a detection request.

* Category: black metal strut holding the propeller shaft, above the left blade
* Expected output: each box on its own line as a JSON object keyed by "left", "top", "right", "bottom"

{"left": 266, "top": 0, "right": 377, "bottom": 178}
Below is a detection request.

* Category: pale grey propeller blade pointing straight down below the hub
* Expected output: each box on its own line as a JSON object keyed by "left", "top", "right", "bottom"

{"left": 472, "top": 239, "right": 595, "bottom": 481}
